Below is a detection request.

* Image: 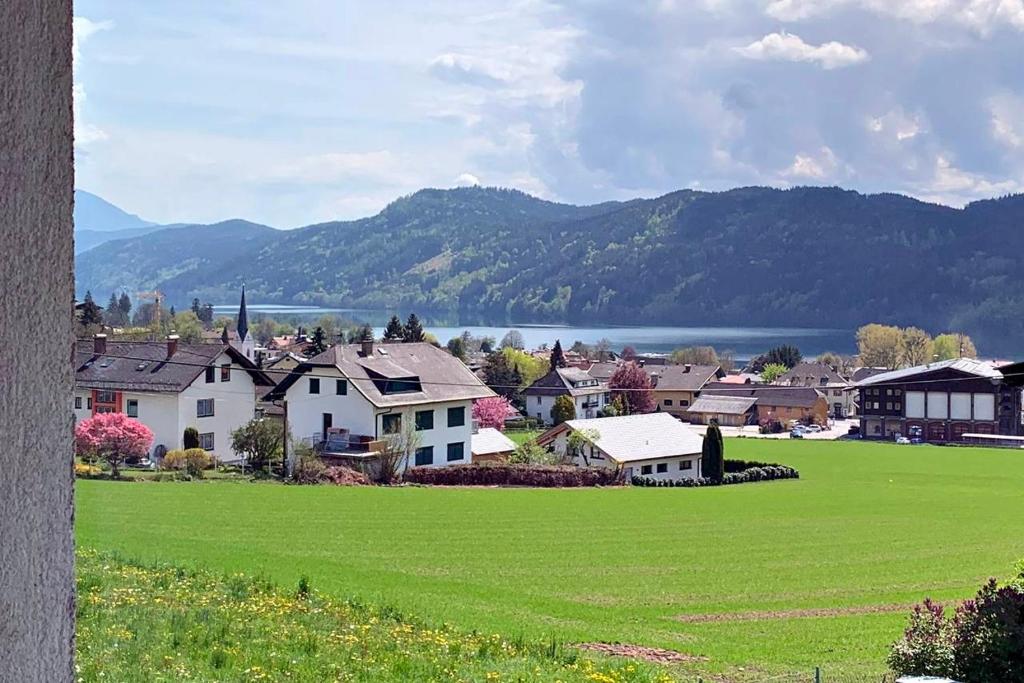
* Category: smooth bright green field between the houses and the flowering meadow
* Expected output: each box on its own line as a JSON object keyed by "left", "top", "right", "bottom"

{"left": 77, "top": 439, "right": 1024, "bottom": 681}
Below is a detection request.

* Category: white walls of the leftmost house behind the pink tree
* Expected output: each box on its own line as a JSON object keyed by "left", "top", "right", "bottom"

{"left": 74, "top": 353, "right": 256, "bottom": 462}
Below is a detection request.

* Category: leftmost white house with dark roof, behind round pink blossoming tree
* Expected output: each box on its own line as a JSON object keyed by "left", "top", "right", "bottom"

{"left": 74, "top": 334, "right": 272, "bottom": 461}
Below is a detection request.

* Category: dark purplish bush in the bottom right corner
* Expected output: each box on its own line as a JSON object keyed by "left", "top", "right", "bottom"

{"left": 889, "top": 565, "right": 1024, "bottom": 683}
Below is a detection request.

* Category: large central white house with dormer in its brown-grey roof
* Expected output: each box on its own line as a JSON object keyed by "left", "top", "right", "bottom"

{"left": 267, "top": 340, "right": 495, "bottom": 467}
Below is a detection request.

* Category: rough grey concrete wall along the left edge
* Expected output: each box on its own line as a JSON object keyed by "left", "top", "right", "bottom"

{"left": 0, "top": 0, "right": 75, "bottom": 682}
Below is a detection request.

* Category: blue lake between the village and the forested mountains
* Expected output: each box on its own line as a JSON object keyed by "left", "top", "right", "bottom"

{"left": 214, "top": 304, "right": 856, "bottom": 360}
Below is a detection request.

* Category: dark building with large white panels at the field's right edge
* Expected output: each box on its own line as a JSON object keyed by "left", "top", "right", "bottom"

{"left": 856, "top": 358, "right": 1024, "bottom": 443}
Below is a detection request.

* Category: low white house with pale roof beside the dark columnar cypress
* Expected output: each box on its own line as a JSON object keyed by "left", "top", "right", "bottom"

{"left": 537, "top": 413, "right": 703, "bottom": 480}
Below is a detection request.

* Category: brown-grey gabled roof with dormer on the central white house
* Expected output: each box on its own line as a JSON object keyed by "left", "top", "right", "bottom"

{"left": 266, "top": 342, "right": 495, "bottom": 408}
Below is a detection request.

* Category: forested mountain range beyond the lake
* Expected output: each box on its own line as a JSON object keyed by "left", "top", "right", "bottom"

{"left": 77, "top": 187, "right": 1024, "bottom": 353}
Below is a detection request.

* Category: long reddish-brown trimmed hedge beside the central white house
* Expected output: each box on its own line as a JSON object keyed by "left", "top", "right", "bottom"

{"left": 404, "top": 463, "right": 624, "bottom": 488}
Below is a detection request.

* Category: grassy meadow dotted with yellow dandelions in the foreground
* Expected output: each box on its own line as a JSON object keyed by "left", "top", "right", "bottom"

{"left": 77, "top": 550, "right": 675, "bottom": 683}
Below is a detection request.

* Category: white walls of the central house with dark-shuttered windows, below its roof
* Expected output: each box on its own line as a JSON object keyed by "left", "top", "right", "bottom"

{"left": 286, "top": 368, "right": 473, "bottom": 467}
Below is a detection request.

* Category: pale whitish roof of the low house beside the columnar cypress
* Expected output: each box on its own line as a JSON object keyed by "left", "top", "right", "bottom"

{"left": 538, "top": 413, "right": 703, "bottom": 463}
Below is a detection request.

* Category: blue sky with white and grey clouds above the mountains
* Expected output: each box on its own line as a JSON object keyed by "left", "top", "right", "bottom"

{"left": 74, "top": 0, "right": 1024, "bottom": 228}
